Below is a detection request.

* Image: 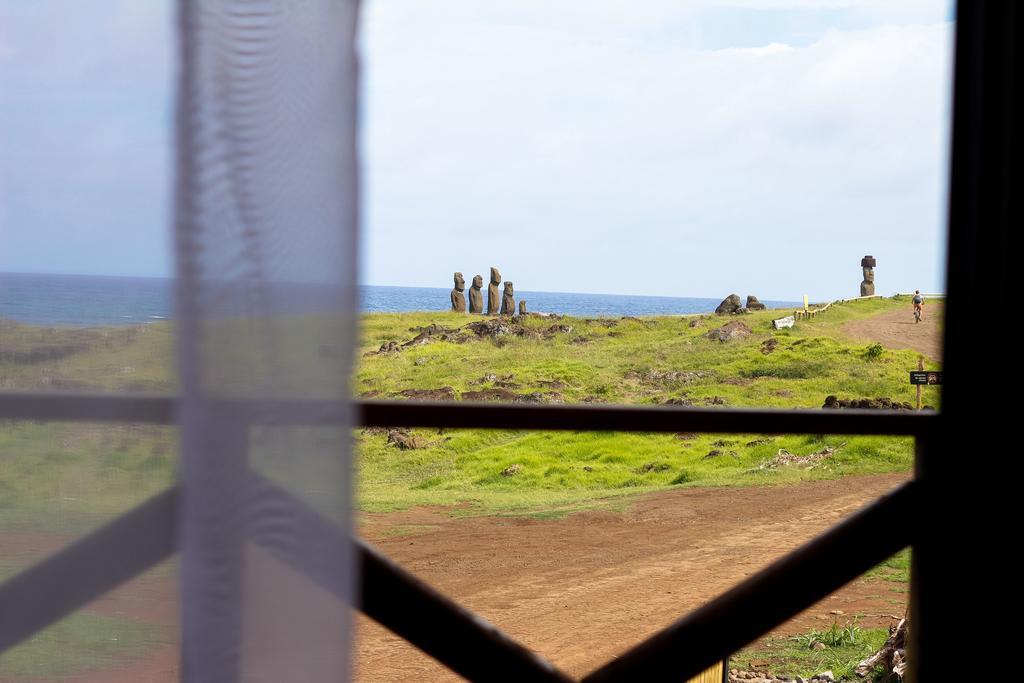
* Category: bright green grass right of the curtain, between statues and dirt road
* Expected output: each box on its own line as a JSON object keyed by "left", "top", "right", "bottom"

{"left": 355, "top": 300, "right": 939, "bottom": 515}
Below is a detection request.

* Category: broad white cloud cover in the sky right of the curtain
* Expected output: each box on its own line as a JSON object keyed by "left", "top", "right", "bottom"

{"left": 365, "top": 2, "right": 950, "bottom": 298}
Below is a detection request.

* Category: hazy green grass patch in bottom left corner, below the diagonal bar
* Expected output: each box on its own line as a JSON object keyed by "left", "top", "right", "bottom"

{"left": 0, "top": 612, "right": 162, "bottom": 681}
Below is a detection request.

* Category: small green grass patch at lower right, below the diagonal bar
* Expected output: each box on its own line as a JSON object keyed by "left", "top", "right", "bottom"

{"left": 729, "top": 622, "right": 889, "bottom": 681}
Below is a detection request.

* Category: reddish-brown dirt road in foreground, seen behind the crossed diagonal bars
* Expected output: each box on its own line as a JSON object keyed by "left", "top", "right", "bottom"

{"left": 0, "top": 474, "right": 907, "bottom": 683}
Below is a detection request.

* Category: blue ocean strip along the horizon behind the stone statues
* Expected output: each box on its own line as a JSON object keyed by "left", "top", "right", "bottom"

{"left": 0, "top": 273, "right": 798, "bottom": 327}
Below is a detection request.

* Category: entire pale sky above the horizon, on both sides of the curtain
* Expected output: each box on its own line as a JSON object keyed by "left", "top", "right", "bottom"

{"left": 0, "top": 0, "right": 953, "bottom": 300}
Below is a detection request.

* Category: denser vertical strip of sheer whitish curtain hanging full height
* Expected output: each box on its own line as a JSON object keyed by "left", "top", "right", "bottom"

{"left": 175, "top": 0, "right": 358, "bottom": 683}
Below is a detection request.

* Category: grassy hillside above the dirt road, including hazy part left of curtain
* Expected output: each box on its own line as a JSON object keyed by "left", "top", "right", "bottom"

{"left": 0, "top": 300, "right": 938, "bottom": 530}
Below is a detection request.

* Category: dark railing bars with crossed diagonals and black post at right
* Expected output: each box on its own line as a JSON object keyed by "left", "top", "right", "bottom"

{"left": 0, "top": 0, "right": 1024, "bottom": 681}
